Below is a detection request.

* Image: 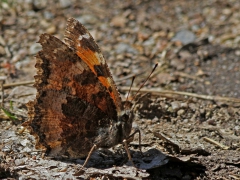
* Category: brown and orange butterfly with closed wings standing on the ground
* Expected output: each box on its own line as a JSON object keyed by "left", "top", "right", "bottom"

{"left": 25, "top": 18, "right": 140, "bottom": 165}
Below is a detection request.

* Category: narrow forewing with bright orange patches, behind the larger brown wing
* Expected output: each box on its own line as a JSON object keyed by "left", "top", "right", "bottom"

{"left": 65, "top": 18, "right": 122, "bottom": 114}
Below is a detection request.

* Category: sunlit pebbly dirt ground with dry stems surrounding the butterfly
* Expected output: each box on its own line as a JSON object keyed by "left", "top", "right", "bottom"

{"left": 0, "top": 0, "right": 240, "bottom": 180}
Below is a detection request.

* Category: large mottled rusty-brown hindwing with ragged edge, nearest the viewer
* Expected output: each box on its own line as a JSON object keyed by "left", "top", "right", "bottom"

{"left": 26, "top": 33, "right": 117, "bottom": 158}
